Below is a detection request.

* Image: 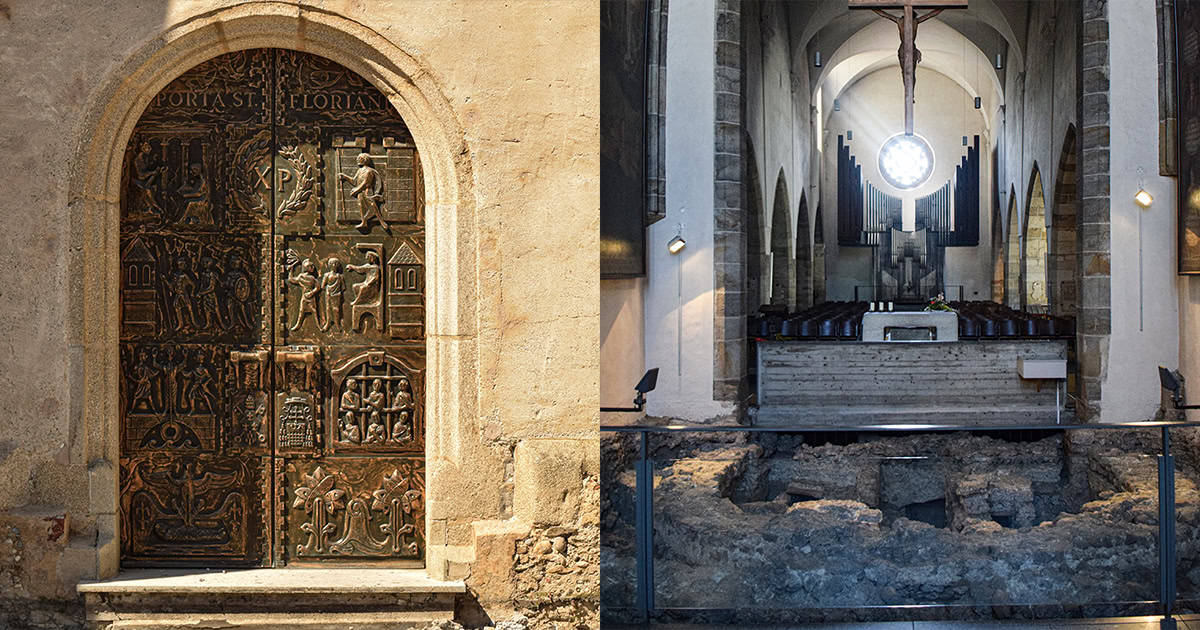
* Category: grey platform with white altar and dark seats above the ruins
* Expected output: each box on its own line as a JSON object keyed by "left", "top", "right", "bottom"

{"left": 750, "top": 302, "right": 1074, "bottom": 426}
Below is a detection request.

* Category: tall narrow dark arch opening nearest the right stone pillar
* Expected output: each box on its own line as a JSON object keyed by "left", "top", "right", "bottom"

{"left": 1048, "top": 125, "right": 1079, "bottom": 317}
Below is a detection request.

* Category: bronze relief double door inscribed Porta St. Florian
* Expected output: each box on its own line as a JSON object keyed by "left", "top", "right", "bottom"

{"left": 120, "top": 49, "right": 425, "bottom": 566}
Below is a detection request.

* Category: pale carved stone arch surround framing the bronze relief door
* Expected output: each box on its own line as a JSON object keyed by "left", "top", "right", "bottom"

{"left": 66, "top": 1, "right": 472, "bottom": 577}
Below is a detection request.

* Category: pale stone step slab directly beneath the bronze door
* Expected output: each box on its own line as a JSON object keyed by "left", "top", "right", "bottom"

{"left": 77, "top": 566, "right": 467, "bottom": 595}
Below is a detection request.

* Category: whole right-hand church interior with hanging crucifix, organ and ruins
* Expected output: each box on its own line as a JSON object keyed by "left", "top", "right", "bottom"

{"left": 600, "top": 0, "right": 1200, "bottom": 626}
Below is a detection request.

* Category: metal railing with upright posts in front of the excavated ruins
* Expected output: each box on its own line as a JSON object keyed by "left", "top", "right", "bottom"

{"left": 600, "top": 422, "right": 1200, "bottom": 628}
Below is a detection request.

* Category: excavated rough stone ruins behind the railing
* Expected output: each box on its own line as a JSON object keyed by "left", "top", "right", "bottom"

{"left": 601, "top": 430, "right": 1200, "bottom": 623}
